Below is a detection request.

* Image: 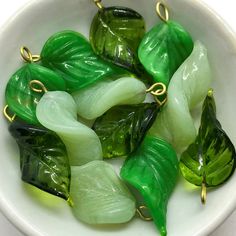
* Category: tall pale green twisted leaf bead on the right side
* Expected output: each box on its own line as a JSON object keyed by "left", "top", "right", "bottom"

{"left": 150, "top": 41, "right": 212, "bottom": 152}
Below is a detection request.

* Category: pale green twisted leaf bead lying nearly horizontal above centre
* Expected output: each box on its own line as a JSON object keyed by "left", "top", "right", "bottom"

{"left": 72, "top": 77, "right": 146, "bottom": 120}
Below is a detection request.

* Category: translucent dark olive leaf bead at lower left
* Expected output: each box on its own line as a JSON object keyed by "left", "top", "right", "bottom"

{"left": 9, "top": 121, "right": 70, "bottom": 200}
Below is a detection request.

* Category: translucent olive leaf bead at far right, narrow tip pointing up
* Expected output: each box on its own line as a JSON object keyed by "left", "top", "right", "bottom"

{"left": 180, "top": 92, "right": 236, "bottom": 187}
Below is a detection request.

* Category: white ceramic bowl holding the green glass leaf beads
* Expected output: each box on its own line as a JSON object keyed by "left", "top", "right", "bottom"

{"left": 0, "top": 0, "right": 236, "bottom": 236}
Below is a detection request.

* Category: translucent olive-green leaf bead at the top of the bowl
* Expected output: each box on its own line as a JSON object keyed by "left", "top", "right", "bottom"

{"left": 90, "top": 7, "right": 145, "bottom": 71}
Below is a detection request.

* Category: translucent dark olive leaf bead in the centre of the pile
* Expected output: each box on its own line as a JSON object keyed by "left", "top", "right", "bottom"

{"left": 93, "top": 103, "right": 159, "bottom": 158}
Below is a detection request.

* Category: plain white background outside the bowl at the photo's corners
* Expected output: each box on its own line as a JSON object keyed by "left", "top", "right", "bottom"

{"left": 0, "top": 0, "right": 236, "bottom": 236}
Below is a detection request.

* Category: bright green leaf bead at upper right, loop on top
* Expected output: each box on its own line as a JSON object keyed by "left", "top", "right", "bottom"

{"left": 138, "top": 21, "right": 193, "bottom": 86}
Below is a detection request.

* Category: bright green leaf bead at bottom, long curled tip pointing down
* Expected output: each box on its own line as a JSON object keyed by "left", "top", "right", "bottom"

{"left": 120, "top": 136, "right": 178, "bottom": 236}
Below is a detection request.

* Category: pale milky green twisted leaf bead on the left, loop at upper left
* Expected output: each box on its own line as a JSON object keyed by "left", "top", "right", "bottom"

{"left": 36, "top": 91, "right": 102, "bottom": 166}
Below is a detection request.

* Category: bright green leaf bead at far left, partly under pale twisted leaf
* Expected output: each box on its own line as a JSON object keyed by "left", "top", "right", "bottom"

{"left": 5, "top": 63, "right": 66, "bottom": 124}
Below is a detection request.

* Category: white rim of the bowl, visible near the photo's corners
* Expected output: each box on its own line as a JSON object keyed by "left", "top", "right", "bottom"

{"left": 0, "top": 0, "right": 236, "bottom": 236}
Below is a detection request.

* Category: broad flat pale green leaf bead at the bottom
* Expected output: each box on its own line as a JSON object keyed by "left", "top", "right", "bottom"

{"left": 70, "top": 161, "right": 136, "bottom": 224}
